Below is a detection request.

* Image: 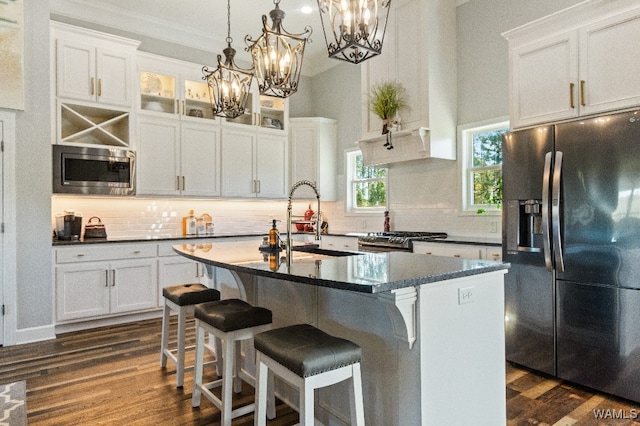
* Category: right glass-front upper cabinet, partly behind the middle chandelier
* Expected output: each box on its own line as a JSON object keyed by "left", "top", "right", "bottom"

{"left": 226, "top": 81, "right": 289, "bottom": 133}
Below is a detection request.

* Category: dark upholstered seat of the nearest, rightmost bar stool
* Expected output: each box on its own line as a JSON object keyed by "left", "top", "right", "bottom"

{"left": 253, "top": 324, "right": 362, "bottom": 377}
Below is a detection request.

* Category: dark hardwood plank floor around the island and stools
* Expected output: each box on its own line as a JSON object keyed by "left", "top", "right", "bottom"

{"left": 0, "top": 319, "right": 640, "bottom": 426}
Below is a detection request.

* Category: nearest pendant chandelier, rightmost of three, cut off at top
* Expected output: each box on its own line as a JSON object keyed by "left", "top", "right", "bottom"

{"left": 318, "top": 0, "right": 391, "bottom": 64}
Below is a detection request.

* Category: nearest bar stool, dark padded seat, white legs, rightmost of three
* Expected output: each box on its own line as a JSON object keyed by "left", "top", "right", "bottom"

{"left": 253, "top": 324, "right": 364, "bottom": 426}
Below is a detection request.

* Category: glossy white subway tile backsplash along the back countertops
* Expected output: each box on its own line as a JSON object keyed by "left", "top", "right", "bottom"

{"left": 51, "top": 196, "right": 502, "bottom": 239}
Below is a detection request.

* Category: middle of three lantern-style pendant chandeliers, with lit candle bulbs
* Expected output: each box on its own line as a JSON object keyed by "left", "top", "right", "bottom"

{"left": 245, "top": 0, "right": 311, "bottom": 98}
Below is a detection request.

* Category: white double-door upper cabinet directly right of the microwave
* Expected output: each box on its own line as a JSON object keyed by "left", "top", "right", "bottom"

{"left": 136, "top": 115, "right": 220, "bottom": 197}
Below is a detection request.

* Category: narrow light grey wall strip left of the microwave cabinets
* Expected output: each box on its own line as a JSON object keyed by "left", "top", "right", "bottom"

{"left": 10, "top": 0, "right": 53, "bottom": 342}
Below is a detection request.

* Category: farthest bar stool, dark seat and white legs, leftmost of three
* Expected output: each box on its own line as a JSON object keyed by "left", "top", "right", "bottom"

{"left": 160, "top": 283, "right": 220, "bottom": 388}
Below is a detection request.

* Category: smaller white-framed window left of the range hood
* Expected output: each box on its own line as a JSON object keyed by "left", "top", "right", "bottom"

{"left": 346, "top": 150, "right": 387, "bottom": 213}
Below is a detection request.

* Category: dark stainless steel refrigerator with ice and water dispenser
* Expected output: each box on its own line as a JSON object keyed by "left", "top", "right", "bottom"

{"left": 503, "top": 111, "right": 640, "bottom": 402}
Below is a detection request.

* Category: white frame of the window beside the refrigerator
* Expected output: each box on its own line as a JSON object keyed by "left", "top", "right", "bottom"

{"left": 458, "top": 116, "right": 510, "bottom": 216}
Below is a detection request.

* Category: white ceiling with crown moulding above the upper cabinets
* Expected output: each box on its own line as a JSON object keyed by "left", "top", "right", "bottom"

{"left": 50, "top": 0, "right": 340, "bottom": 76}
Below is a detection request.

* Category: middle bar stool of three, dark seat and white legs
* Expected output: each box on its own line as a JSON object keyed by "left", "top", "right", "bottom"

{"left": 191, "top": 299, "right": 275, "bottom": 426}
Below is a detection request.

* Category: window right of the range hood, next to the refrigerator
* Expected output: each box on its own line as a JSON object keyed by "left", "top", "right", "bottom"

{"left": 459, "top": 119, "right": 509, "bottom": 213}
